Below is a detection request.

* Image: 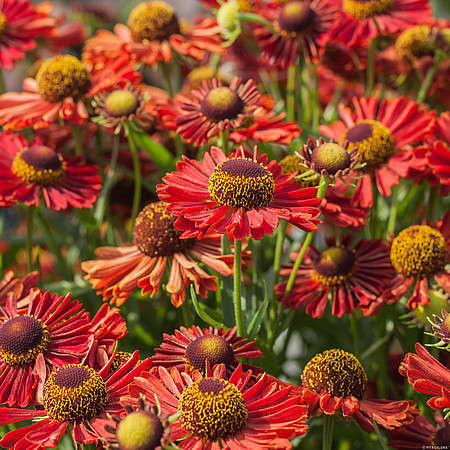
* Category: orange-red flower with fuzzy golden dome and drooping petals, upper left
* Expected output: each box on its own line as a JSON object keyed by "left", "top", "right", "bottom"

{"left": 0, "top": 55, "right": 141, "bottom": 130}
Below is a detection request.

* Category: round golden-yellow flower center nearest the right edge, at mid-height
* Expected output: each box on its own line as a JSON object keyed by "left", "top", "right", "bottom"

{"left": 391, "top": 225, "right": 447, "bottom": 277}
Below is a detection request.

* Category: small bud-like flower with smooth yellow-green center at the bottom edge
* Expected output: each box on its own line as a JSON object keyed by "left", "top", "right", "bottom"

{"left": 104, "top": 398, "right": 170, "bottom": 450}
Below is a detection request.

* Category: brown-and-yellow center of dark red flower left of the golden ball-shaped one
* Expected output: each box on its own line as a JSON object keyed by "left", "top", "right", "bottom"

{"left": 313, "top": 247, "right": 355, "bottom": 286}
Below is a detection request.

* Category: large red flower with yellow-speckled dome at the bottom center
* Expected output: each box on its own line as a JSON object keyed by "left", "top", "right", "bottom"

{"left": 122, "top": 364, "right": 307, "bottom": 450}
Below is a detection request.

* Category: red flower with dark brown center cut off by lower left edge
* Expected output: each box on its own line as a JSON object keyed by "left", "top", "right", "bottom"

{"left": 0, "top": 290, "right": 91, "bottom": 407}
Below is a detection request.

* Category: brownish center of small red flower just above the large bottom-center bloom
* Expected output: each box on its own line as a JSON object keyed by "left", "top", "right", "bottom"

{"left": 185, "top": 334, "right": 234, "bottom": 371}
